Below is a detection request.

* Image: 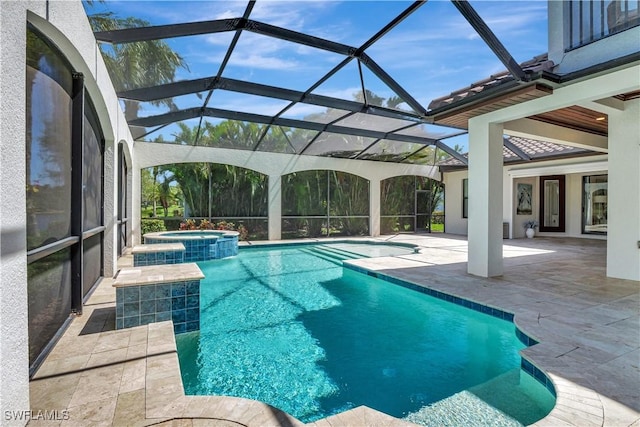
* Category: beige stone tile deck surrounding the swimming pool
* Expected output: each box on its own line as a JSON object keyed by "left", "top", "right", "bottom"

{"left": 29, "top": 235, "right": 640, "bottom": 427}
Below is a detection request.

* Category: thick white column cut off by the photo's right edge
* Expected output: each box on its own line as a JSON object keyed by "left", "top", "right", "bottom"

{"left": 607, "top": 99, "right": 640, "bottom": 280}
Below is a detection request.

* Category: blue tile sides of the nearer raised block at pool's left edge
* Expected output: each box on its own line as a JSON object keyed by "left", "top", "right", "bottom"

{"left": 116, "top": 280, "right": 200, "bottom": 333}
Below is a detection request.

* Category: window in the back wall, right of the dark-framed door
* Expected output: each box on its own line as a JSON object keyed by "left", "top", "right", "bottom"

{"left": 582, "top": 175, "right": 608, "bottom": 234}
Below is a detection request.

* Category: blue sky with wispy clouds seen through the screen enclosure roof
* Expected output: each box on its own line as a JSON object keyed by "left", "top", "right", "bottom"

{"left": 85, "top": 0, "right": 548, "bottom": 150}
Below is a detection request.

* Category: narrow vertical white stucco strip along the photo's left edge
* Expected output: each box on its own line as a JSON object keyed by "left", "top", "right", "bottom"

{"left": 0, "top": 2, "right": 36, "bottom": 425}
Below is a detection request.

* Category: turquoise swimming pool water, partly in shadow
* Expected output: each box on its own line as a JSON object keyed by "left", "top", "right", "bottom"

{"left": 176, "top": 246, "right": 554, "bottom": 425}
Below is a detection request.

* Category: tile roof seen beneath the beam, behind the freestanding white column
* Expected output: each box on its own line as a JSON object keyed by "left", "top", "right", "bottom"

{"left": 438, "top": 136, "right": 595, "bottom": 167}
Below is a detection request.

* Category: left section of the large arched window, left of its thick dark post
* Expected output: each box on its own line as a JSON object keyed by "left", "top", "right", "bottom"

{"left": 25, "top": 31, "right": 78, "bottom": 363}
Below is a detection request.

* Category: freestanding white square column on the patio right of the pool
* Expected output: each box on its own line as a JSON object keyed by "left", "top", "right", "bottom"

{"left": 467, "top": 119, "right": 503, "bottom": 277}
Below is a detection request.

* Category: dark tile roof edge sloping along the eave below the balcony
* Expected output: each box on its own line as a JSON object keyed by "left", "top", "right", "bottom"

{"left": 428, "top": 53, "right": 554, "bottom": 110}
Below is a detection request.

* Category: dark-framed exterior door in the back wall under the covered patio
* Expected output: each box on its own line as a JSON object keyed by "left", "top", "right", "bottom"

{"left": 540, "top": 175, "right": 565, "bottom": 232}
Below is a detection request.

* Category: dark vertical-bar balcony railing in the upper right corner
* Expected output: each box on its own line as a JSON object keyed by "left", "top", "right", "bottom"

{"left": 566, "top": 0, "right": 640, "bottom": 50}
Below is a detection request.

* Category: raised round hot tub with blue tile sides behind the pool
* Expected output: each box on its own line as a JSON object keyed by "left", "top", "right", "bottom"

{"left": 143, "top": 230, "right": 238, "bottom": 262}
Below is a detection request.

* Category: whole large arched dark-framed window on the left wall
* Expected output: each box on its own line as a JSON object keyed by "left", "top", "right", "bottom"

{"left": 25, "top": 28, "right": 104, "bottom": 373}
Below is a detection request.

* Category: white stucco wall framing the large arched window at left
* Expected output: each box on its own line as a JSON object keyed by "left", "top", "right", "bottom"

{"left": 0, "top": 0, "right": 132, "bottom": 425}
